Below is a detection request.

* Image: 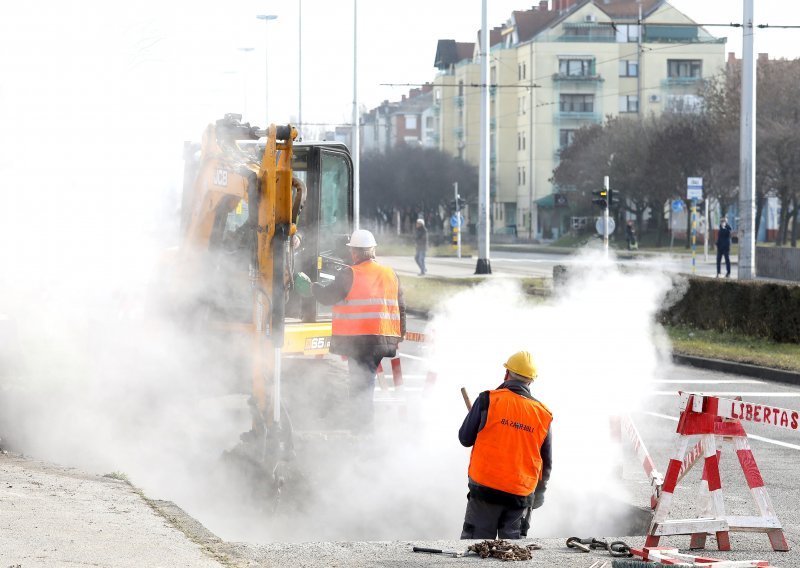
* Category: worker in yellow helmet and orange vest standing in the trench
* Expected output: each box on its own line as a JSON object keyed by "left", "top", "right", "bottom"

{"left": 458, "top": 351, "right": 553, "bottom": 539}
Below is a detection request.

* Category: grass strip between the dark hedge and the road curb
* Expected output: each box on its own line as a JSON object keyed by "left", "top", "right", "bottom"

{"left": 666, "top": 325, "right": 800, "bottom": 372}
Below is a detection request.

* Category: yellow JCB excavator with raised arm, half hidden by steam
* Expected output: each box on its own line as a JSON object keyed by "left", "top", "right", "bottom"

{"left": 178, "top": 114, "right": 353, "bottom": 504}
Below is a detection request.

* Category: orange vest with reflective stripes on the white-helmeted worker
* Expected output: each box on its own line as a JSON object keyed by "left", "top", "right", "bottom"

{"left": 332, "top": 260, "right": 400, "bottom": 337}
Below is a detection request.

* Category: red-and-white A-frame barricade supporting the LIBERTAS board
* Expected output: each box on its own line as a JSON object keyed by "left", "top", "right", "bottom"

{"left": 645, "top": 392, "right": 799, "bottom": 551}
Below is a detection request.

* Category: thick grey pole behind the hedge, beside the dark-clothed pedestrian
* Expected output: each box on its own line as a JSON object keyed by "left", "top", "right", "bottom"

{"left": 736, "top": 0, "right": 756, "bottom": 280}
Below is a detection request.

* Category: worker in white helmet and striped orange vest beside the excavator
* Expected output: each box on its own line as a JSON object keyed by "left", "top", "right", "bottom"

{"left": 295, "top": 229, "right": 406, "bottom": 432}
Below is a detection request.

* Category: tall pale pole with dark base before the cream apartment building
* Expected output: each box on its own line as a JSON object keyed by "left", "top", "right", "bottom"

{"left": 475, "top": 0, "right": 492, "bottom": 274}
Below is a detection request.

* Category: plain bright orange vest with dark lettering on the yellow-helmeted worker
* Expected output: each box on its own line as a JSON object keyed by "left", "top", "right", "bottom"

{"left": 469, "top": 389, "right": 553, "bottom": 497}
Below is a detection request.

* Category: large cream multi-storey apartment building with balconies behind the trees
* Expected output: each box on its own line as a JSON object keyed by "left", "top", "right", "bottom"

{"left": 431, "top": 0, "right": 725, "bottom": 238}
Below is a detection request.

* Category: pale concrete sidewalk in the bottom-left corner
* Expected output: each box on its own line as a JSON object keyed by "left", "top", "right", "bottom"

{"left": 0, "top": 452, "right": 225, "bottom": 568}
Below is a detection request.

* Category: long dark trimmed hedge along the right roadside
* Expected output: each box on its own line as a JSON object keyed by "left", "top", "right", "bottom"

{"left": 659, "top": 277, "right": 800, "bottom": 343}
